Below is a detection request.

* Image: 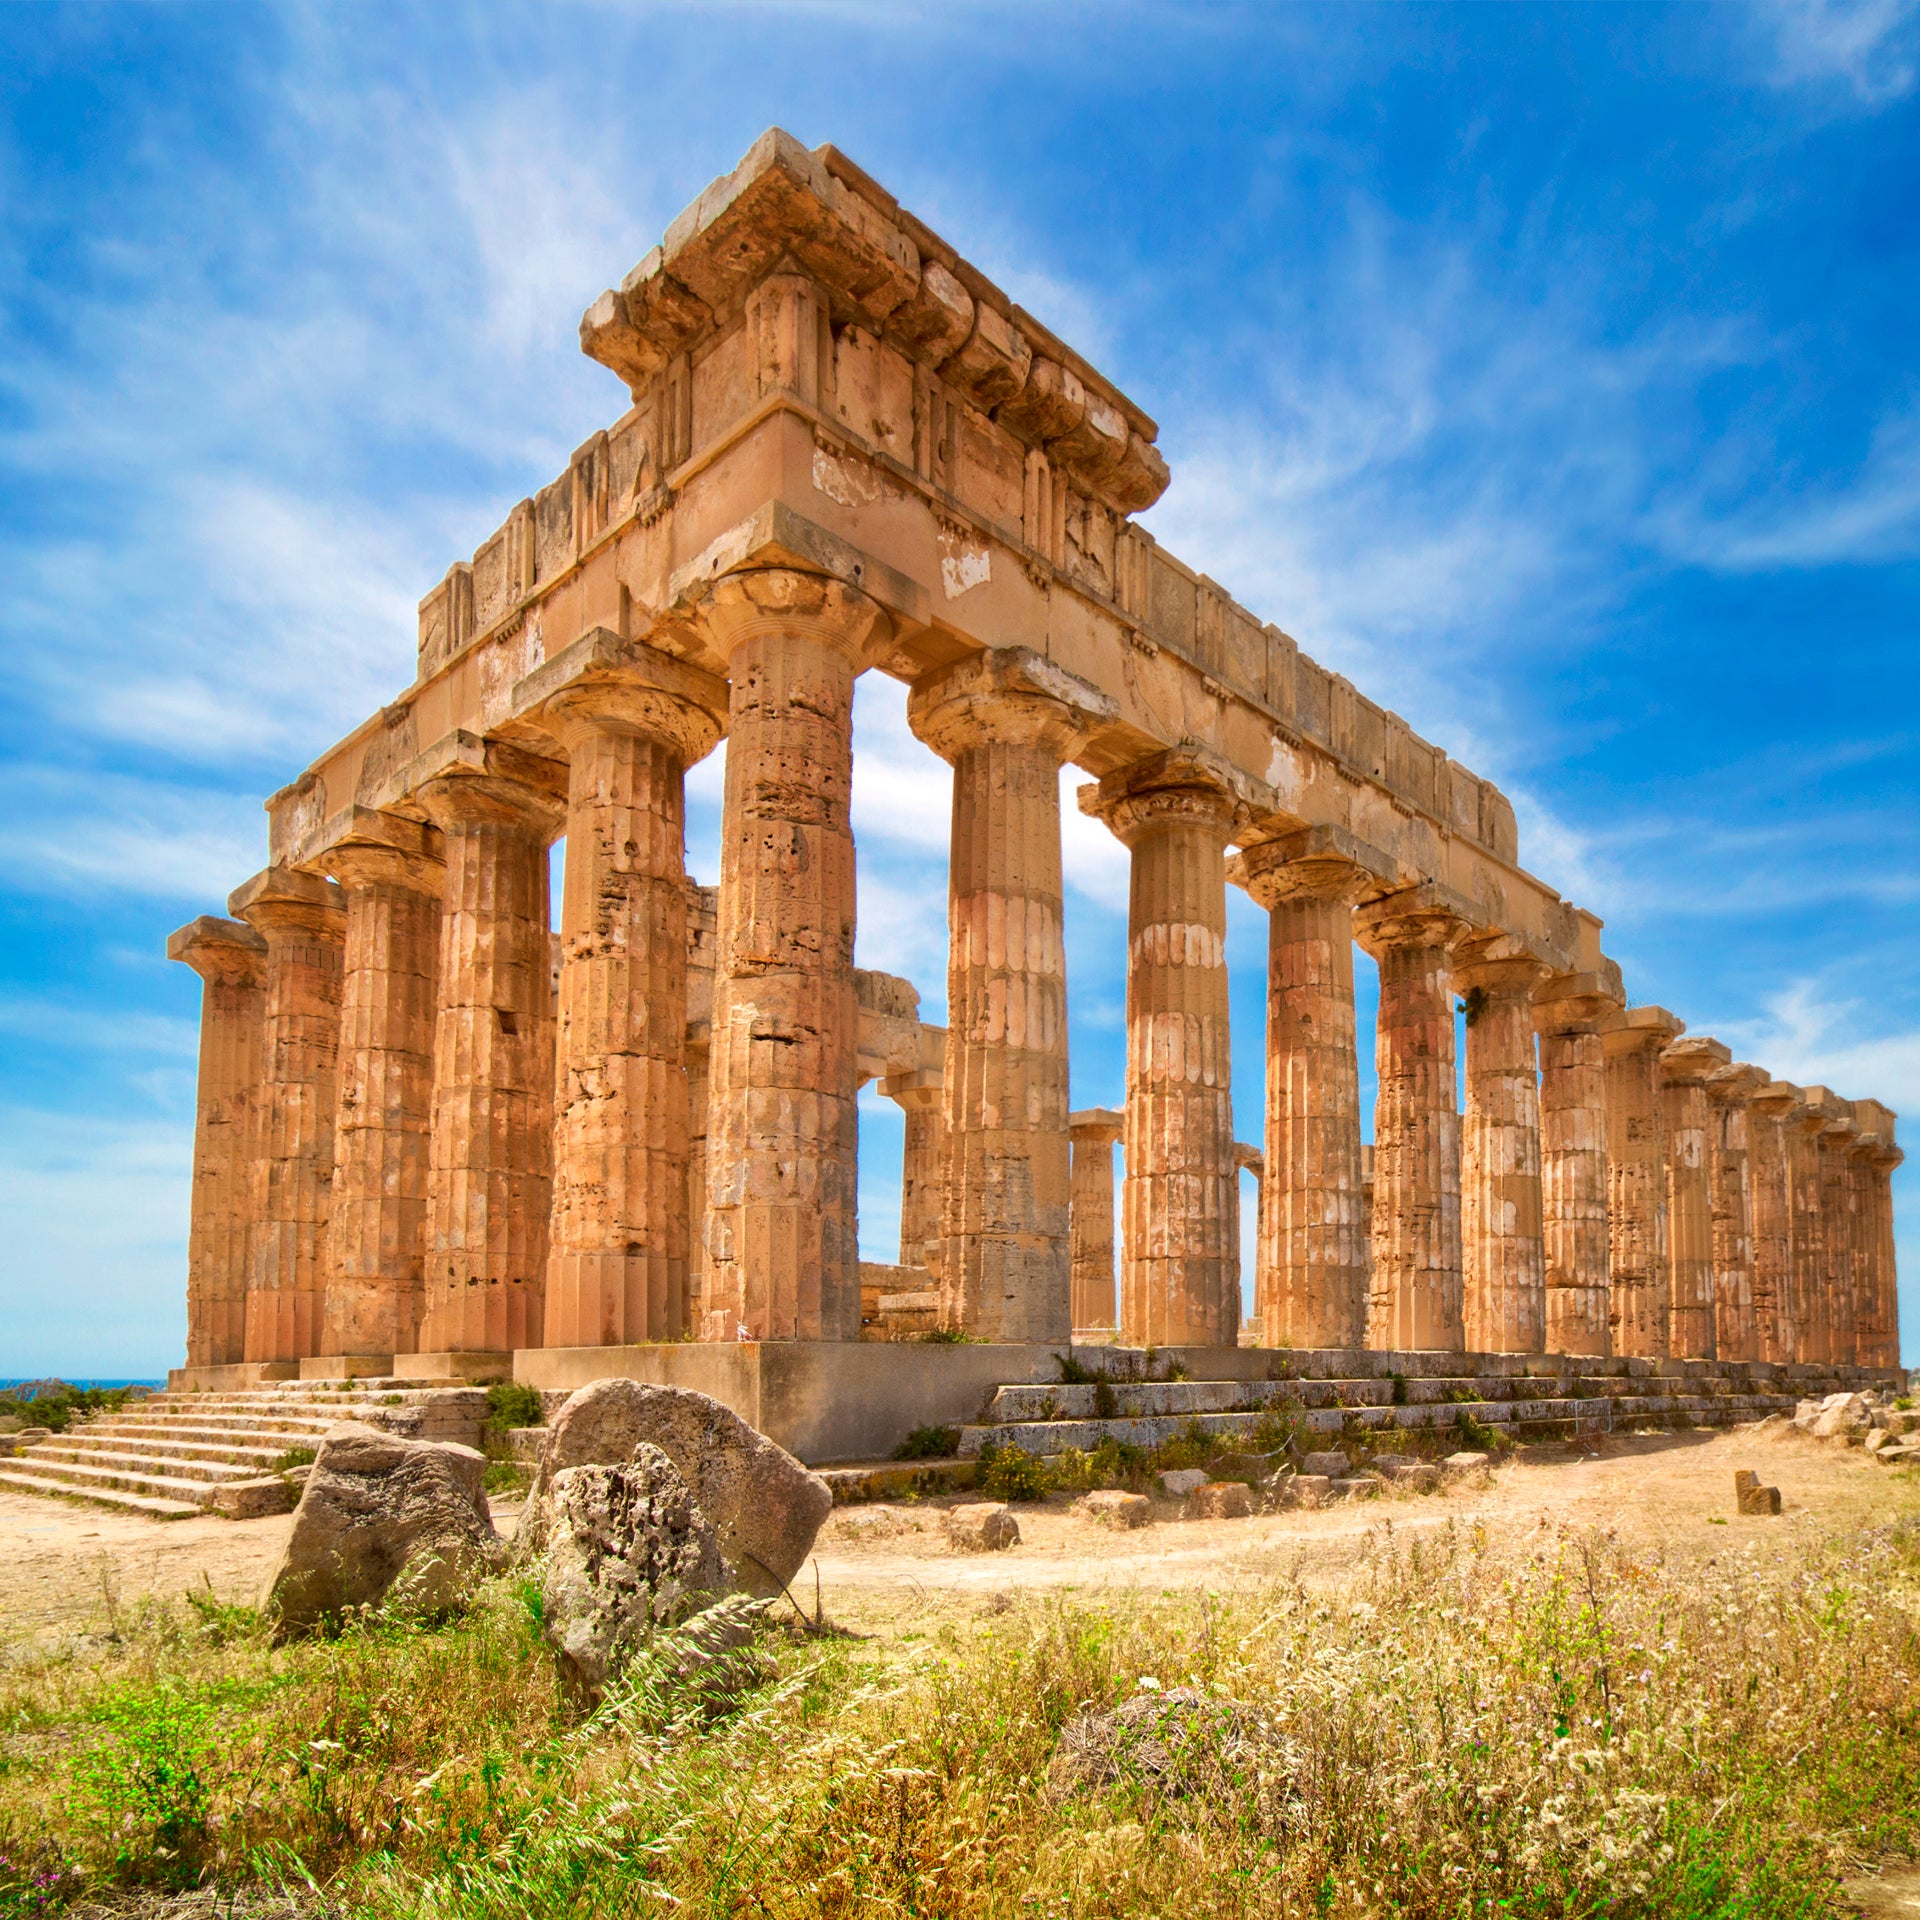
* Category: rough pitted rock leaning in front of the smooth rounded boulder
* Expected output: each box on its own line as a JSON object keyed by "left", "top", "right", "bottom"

{"left": 540, "top": 1440, "right": 726, "bottom": 1699}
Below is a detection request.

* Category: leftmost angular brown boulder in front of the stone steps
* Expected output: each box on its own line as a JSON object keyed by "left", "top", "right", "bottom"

{"left": 261, "top": 1421, "right": 501, "bottom": 1640}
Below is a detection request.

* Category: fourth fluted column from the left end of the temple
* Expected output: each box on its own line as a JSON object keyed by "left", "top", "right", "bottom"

{"left": 417, "top": 741, "right": 564, "bottom": 1354}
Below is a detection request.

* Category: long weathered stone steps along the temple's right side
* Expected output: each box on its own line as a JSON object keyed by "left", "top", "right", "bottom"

{"left": 958, "top": 1352, "right": 1882, "bottom": 1459}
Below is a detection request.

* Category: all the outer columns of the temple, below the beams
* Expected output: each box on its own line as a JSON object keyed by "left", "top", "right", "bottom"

{"left": 175, "top": 568, "right": 1897, "bottom": 1365}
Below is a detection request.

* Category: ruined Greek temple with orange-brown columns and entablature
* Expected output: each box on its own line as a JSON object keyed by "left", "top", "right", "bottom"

{"left": 167, "top": 131, "right": 1901, "bottom": 1444}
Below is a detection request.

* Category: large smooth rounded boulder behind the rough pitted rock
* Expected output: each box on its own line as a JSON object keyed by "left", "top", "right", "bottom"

{"left": 520, "top": 1380, "right": 833, "bottom": 1597}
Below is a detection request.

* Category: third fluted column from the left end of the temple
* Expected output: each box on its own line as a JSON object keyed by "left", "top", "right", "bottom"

{"left": 317, "top": 806, "right": 445, "bottom": 1371}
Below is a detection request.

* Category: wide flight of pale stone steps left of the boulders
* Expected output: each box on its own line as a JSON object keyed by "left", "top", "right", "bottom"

{"left": 0, "top": 1380, "right": 486, "bottom": 1521}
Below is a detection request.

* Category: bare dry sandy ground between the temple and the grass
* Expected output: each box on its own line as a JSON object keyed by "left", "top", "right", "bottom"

{"left": 0, "top": 1423, "right": 1920, "bottom": 1638}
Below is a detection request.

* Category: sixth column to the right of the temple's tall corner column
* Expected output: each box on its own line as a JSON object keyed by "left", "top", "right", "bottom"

{"left": 1534, "top": 964, "right": 1622, "bottom": 1356}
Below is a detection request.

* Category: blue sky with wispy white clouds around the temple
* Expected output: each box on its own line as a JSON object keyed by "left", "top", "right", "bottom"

{"left": 0, "top": 0, "right": 1920, "bottom": 1375}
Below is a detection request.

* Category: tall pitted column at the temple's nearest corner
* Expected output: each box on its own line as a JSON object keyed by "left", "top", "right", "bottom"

{"left": 701, "top": 568, "right": 889, "bottom": 1340}
